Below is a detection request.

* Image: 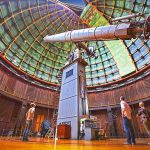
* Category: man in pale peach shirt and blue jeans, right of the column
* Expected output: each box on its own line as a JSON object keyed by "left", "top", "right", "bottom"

{"left": 120, "top": 96, "right": 136, "bottom": 145}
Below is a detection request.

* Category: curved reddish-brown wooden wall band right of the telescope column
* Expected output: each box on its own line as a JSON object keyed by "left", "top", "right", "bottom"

{"left": 88, "top": 76, "right": 150, "bottom": 108}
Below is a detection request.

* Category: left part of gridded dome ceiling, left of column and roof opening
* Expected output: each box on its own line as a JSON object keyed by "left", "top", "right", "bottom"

{"left": 0, "top": 0, "right": 85, "bottom": 84}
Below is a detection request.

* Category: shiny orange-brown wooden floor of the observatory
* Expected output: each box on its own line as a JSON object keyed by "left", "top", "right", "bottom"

{"left": 0, "top": 137, "right": 150, "bottom": 150}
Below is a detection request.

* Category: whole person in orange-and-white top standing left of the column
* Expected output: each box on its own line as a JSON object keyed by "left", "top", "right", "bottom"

{"left": 22, "top": 103, "right": 36, "bottom": 141}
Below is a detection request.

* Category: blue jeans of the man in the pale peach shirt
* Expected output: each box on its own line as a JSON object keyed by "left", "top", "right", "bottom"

{"left": 123, "top": 117, "right": 135, "bottom": 144}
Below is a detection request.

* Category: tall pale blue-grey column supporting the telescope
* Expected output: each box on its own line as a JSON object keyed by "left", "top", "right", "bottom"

{"left": 57, "top": 58, "right": 88, "bottom": 139}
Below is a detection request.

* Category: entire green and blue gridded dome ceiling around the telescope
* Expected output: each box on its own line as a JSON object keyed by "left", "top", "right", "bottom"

{"left": 0, "top": 0, "right": 150, "bottom": 86}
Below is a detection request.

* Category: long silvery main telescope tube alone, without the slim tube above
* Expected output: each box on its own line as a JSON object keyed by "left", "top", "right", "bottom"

{"left": 44, "top": 23, "right": 143, "bottom": 42}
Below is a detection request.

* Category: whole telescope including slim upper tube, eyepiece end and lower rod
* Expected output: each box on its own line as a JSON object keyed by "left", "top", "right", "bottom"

{"left": 44, "top": 14, "right": 150, "bottom": 58}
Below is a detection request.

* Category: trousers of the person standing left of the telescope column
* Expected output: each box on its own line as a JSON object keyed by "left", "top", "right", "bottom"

{"left": 23, "top": 120, "right": 32, "bottom": 140}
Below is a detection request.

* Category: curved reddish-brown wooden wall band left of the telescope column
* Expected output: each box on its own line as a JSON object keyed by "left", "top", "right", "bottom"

{"left": 0, "top": 66, "right": 59, "bottom": 108}
